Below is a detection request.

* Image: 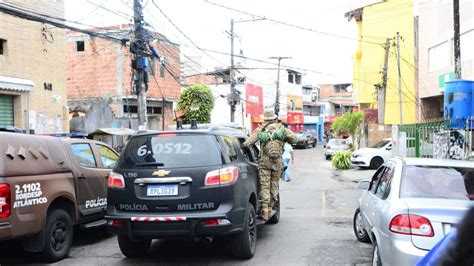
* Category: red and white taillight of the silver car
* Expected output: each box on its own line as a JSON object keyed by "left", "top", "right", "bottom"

{"left": 390, "top": 214, "right": 434, "bottom": 237}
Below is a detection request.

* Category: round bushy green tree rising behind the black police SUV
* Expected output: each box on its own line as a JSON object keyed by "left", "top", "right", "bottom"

{"left": 177, "top": 85, "right": 214, "bottom": 123}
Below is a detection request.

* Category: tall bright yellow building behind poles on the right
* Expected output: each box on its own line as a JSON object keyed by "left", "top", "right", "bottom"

{"left": 346, "top": 0, "right": 418, "bottom": 124}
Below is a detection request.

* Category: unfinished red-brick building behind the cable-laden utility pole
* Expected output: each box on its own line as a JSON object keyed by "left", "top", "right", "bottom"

{"left": 66, "top": 25, "right": 181, "bottom": 132}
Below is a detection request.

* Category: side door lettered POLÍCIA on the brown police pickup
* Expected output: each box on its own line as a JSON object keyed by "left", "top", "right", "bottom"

{"left": 71, "top": 143, "right": 110, "bottom": 219}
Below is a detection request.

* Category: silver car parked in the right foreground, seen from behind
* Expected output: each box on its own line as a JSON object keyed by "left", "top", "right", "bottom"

{"left": 354, "top": 158, "right": 474, "bottom": 265}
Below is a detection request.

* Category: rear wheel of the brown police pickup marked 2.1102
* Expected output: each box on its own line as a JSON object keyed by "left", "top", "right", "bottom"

{"left": 40, "top": 209, "right": 74, "bottom": 262}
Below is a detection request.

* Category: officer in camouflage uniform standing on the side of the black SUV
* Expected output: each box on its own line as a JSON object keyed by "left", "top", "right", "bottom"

{"left": 243, "top": 109, "right": 298, "bottom": 221}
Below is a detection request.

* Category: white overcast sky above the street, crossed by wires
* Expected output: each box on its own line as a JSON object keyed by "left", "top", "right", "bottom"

{"left": 65, "top": 0, "right": 377, "bottom": 84}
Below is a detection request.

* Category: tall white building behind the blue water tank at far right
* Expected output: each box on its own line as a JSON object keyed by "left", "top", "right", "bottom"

{"left": 416, "top": 0, "right": 474, "bottom": 119}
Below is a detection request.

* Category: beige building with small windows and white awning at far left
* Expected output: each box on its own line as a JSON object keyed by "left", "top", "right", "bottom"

{"left": 0, "top": 0, "right": 69, "bottom": 134}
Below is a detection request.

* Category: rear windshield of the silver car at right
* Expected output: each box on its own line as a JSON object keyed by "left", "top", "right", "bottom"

{"left": 400, "top": 166, "right": 474, "bottom": 200}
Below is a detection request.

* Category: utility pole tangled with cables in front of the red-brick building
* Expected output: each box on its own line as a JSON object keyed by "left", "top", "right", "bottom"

{"left": 130, "top": 0, "right": 148, "bottom": 130}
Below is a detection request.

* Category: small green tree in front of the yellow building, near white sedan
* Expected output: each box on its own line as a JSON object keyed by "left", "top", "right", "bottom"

{"left": 331, "top": 112, "right": 364, "bottom": 150}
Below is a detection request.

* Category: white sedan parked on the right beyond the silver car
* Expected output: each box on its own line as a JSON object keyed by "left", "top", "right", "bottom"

{"left": 351, "top": 139, "right": 392, "bottom": 169}
